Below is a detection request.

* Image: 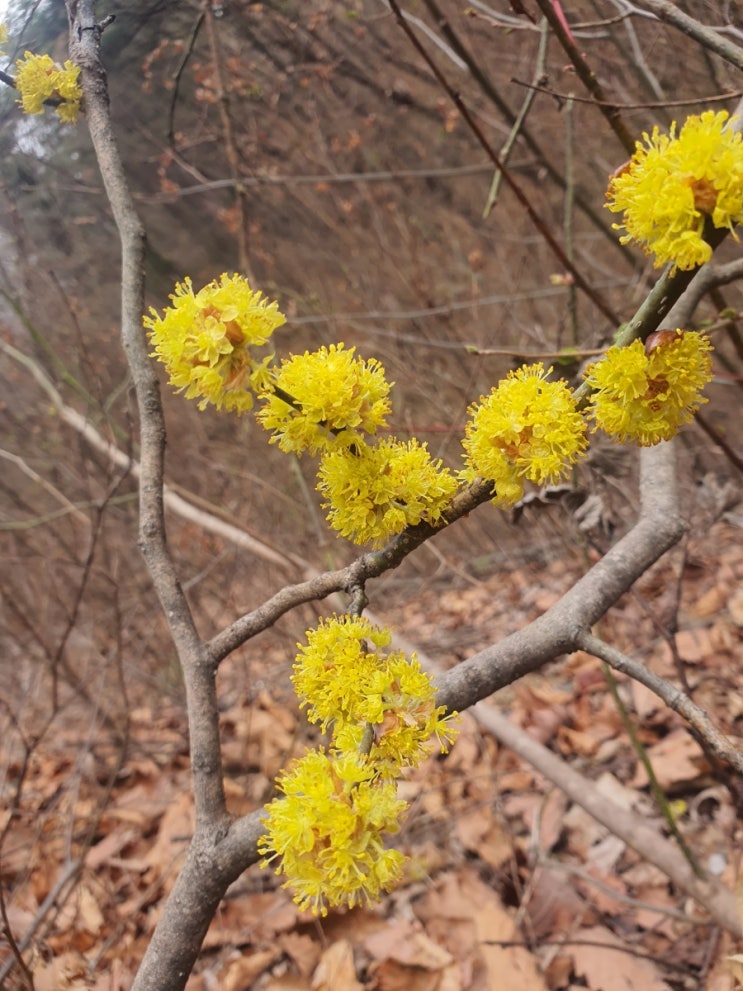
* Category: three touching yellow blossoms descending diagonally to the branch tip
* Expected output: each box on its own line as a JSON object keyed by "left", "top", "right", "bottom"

{"left": 143, "top": 275, "right": 457, "bottom": 546}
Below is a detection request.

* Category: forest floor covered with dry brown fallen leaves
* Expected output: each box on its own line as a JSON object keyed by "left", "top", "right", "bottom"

{"left": 0, "top": 522, "right": 743, "bottom": 991}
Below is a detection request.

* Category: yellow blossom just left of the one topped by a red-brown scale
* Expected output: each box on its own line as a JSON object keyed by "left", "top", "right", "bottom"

{"left": 461, "top": 362, "right": 587, "bottom": 505}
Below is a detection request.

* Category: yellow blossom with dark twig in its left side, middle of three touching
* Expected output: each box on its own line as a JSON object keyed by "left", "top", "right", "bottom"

{"left": 258, "top": 344, "right": 390, "bottom": 454}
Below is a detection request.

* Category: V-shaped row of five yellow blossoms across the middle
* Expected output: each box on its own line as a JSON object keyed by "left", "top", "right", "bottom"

{"left": 144, "top": 274, "right": 712, "bottom": 547}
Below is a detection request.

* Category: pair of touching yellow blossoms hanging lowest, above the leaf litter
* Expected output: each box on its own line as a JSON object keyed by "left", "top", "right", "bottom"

{"left": 258, "top": 616, "right": 455, "bottom": 915}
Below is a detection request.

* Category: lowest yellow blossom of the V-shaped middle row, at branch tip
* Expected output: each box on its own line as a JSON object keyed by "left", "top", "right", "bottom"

{"left": 317, "top": 438, "right": 457, "bottom": 547}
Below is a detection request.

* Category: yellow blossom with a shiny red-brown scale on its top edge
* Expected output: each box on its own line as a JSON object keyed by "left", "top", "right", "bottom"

{"left": 586, "top": 330, "right": 712, "bottom": 447}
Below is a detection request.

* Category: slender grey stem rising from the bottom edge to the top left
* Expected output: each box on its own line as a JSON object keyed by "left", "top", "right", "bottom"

{"left": 67, "top": 0, "right": 234, "bottom": 989}
